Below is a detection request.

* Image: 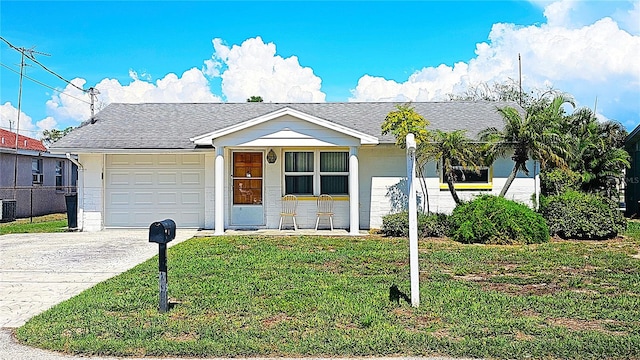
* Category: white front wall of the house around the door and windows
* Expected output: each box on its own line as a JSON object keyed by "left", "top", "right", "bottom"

{"left": 78, "top": 143, "right": 535, "bottom": 231}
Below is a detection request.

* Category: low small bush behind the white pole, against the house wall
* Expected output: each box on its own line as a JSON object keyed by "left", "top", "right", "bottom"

{"left": 381, "top": 211, "right": 449, "bottom": 238}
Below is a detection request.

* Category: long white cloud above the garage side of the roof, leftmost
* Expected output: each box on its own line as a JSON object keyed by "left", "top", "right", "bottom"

{"left": 47, "top": 68, "right": 221, "bottom": 122}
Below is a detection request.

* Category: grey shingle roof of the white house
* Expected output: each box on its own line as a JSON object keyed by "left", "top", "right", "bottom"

{"left": 51, "top": 101, "right": 521, "bottom": 150}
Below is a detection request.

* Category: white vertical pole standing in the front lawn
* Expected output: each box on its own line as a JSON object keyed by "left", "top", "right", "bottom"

{"left": 406, "top": 134, "right": 420, "bottom": 307}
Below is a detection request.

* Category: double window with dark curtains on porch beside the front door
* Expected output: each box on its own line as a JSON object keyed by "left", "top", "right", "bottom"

{"left": 284, "top": 151, "right": 349, "bottom": 195}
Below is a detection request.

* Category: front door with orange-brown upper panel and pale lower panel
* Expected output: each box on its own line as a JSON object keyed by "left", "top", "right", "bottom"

{"left": 231, "top": 151, "right": 264, "bottom": 226}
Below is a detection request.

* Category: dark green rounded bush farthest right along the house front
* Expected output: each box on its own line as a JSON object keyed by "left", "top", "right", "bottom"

{"left": 541, "top": 190, "right": 627, "bottom": 240}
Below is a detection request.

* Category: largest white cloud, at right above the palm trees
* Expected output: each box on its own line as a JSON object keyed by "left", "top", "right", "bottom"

{"left": 350, "top": 1, "right": 640, "bottom": 128}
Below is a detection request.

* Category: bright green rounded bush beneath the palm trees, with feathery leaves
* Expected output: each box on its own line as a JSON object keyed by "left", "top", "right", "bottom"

{"left": 450, "top": 195, "right": 549, "bottom": 244}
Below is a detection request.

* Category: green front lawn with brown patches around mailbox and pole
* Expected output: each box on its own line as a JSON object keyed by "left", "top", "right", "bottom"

{"left": 16, "top": 229, "right": 640, "bottom": 359}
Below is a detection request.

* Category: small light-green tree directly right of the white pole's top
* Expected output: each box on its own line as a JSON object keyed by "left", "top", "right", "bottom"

{"left": 425, "top": 130, "right": 481, "bottom": 205}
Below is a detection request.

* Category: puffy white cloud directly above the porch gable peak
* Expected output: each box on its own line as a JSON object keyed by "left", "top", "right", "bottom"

{"left": 204, "top": 37, "right": 325, "bottom": 102}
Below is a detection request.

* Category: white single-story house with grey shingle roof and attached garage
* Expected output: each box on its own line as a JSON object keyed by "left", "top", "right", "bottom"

{"left": 51, "top": 102, "right": 536, "bottom": 235}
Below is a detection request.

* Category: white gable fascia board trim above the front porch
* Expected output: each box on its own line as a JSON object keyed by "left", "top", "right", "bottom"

{"left": 189, "top": 107, "right": 378, "bottom": 146}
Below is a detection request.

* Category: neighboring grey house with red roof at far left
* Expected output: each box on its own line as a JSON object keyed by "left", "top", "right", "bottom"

{"left": 0, "top": 129, "right": 77, "bottom": 217}
